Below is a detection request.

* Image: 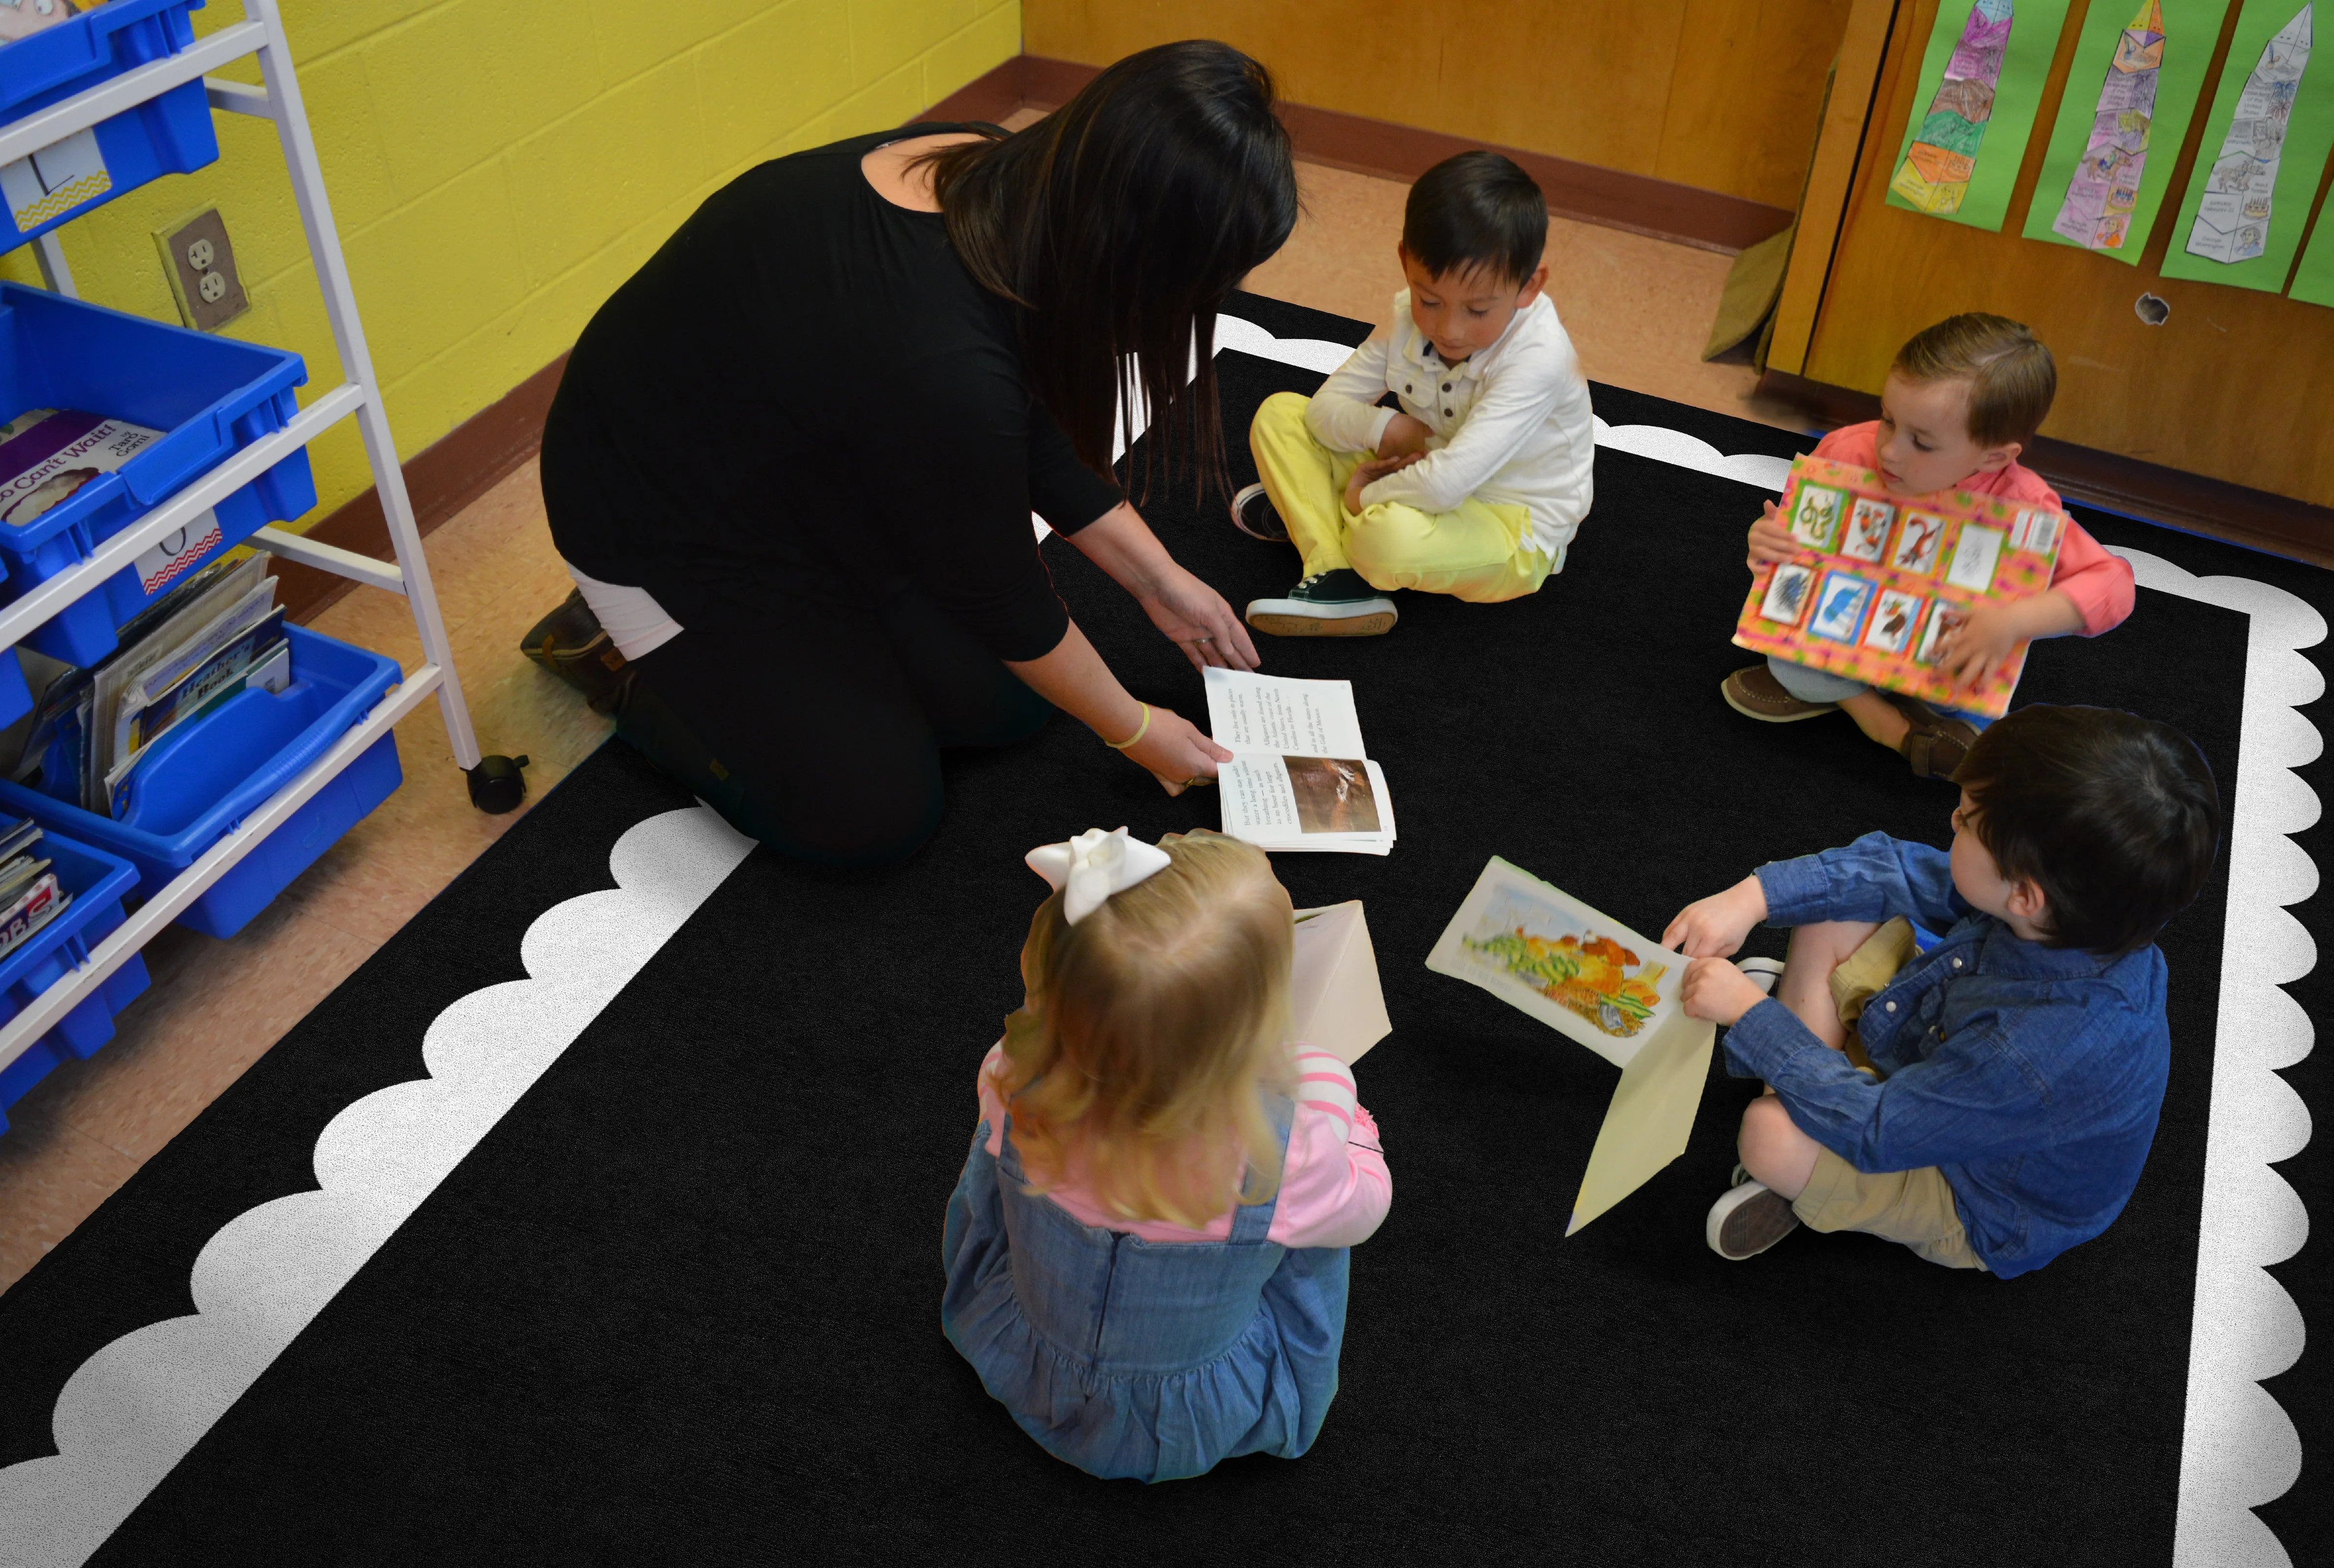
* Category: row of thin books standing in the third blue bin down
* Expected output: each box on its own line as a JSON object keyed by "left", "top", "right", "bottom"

{"left": 14, "top": 555, "right": 292, "bottom": 819}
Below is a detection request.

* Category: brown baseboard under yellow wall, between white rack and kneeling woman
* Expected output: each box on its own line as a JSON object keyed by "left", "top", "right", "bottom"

{"left": 275, "top": 355, "right": 567, "bottom": 623}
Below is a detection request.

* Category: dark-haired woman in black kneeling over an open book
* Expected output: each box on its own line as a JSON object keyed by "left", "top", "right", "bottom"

{"left": 541, "top": 44, "right": 1298, "bottom": 863}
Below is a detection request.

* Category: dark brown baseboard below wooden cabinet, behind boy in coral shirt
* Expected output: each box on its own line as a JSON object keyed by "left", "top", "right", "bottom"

{"left": 1758, "top": 371, "right": 2334, "bottom": 567}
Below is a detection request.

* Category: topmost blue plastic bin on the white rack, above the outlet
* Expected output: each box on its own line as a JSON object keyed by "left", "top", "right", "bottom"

{"left": 0, "top": 0, "right": 220, "bottom": 252}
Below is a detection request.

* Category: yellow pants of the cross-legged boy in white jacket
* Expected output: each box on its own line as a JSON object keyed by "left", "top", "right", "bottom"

{"left": 1249, "top": 392, "right": 1557, "bottom": 604}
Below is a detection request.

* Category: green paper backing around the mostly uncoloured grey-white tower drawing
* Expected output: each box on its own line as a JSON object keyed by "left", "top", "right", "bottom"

{"left": 2163, "top": 0, "right": 2334, "bottom": 294}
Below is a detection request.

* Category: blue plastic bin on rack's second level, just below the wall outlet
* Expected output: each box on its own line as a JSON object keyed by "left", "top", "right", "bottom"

{"left": 0, "top": 284, "right": 315, "bottom": 667}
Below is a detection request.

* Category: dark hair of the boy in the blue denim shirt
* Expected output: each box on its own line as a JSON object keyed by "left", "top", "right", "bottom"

{"left": 1954, "top": 707, "right": 2220, "bottom": 956}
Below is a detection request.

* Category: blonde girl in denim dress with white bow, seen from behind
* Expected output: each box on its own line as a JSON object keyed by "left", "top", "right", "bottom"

{"left": 940, "top": 828, "right": 1394, "bottom": 1482}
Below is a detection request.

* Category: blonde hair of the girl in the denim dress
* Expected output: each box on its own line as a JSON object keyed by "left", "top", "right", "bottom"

{"left": 990, "top": 833, "right": 1295, "bottom": 1227}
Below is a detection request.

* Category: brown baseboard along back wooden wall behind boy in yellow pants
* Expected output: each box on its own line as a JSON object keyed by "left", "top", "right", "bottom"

{"left": 931, "top": 54, "right": 1790, "bottom": 252}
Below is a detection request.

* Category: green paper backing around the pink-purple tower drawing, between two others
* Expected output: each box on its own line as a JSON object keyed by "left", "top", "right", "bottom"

{"left": 2024, "top": 0, "right": 2229, "bottom": 266}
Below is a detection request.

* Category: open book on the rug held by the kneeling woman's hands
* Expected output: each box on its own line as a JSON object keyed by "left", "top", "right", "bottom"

{"left": 1206, "top": 670, "right": 1394, "bottom": 854}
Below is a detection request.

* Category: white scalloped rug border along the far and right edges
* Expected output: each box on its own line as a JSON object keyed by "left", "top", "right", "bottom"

{"left": 1216, "top": 315, "right": 2327, "bottom": 1568}
